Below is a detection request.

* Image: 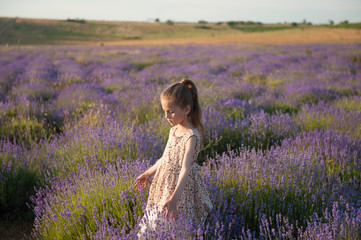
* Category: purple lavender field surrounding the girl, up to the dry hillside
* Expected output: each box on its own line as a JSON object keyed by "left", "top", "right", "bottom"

{"left": 0, "top": 44, "right": 361, "bottom": 239}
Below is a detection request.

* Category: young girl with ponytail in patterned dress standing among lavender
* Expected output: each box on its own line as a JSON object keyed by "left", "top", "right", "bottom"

{"left": 134, "top": 79, "right": 212, "bottom": 232}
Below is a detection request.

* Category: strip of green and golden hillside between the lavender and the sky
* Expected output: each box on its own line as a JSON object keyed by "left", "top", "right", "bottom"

{"left": 0, "top": 18, "right": 361, "bottom": 45}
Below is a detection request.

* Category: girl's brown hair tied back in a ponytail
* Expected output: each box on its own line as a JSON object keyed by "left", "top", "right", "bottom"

{"left": 160, "top": 79, "right": 204, "bottom": 134}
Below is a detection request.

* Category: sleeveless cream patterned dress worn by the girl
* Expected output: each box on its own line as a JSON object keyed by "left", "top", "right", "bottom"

{"left": 137, "top": 126, "right": 213, "bottom": 235}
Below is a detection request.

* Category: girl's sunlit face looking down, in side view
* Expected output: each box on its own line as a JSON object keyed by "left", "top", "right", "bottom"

{"left": 160, "top": 98, "right": 190, "bottom": 126}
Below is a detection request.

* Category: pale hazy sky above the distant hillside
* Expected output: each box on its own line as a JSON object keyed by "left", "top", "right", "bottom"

{"left": 0, "top": 0, "right": 361, "bottom": 24}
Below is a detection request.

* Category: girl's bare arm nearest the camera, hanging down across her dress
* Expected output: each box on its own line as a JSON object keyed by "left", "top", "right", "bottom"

{"left": 163, "top": 136, "right": 197, "bottom": 220}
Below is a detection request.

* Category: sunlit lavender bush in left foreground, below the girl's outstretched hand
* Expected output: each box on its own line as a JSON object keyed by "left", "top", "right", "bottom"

{"left": 28, "top": 158, "right": 150, "bottom": 239}
